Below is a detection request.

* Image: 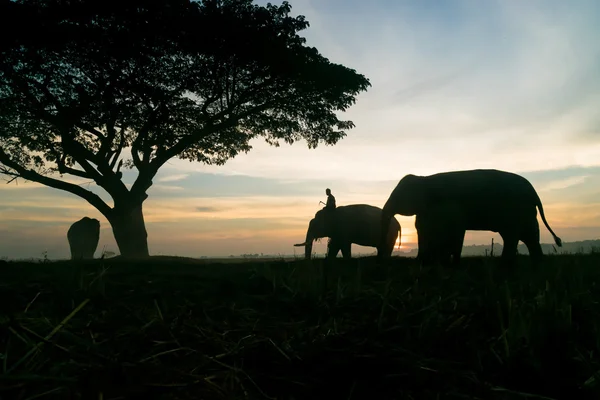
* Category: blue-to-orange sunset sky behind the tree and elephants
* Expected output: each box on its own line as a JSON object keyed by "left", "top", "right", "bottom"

{"left": 0, "top": 0, "right": 600, "bottom": 259}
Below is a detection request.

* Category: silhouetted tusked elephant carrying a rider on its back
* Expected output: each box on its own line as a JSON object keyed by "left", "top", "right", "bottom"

{"left": 294, "top": 204, "right": 401, "bottom": 259}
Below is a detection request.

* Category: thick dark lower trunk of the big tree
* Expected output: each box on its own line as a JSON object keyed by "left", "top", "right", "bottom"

{"left": 109, "top": 204, "right": 150, "bottom": 258}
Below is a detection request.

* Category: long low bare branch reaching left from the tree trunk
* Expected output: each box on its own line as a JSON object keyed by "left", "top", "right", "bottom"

{"left": 0, "top": 149, "right": 112, "bottom": 219}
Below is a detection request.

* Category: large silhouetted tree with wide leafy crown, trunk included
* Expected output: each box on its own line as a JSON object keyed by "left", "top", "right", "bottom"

{"left": 0, "top": 0, "right": 370, "bottom": 257}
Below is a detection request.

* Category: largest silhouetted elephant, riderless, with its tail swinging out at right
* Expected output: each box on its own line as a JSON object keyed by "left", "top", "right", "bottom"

{"left": 380, "top": 169, "right": 562, "bottom": 263}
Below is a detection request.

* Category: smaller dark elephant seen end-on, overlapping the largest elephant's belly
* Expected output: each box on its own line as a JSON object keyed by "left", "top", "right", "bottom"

{"left": 415, "top": 203, "right": 466, "bottom": 265}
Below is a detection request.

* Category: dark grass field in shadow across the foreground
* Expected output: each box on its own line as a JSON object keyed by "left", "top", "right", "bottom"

{"left": 0, "top": 254, "right": 600, "bottom": 400}
